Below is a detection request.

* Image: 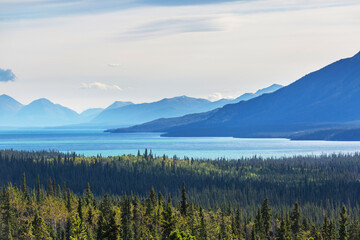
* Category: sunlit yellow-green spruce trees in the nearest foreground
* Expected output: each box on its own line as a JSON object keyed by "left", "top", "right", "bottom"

{"left": 0, "top": 174, "right": 360, "bottom": 240}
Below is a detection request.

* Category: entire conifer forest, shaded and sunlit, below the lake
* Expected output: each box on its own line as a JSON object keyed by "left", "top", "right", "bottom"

{"left": 0, "top": 150, "right": 360, "bottom": 240}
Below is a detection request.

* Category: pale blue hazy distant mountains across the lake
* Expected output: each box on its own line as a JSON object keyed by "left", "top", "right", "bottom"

{"left": 0, "top": 84, "right": 282, "bottom": 128}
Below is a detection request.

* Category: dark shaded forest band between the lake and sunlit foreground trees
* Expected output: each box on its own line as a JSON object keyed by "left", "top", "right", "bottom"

{"left": 0, "top": 150, "right": 360, "bottom": 216}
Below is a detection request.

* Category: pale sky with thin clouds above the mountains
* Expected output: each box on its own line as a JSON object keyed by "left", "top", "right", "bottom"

{"left": 0, "top": 0, "right": 360, "bottom": 112}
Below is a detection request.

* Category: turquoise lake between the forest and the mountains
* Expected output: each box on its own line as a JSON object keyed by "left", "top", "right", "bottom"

{"left": 0, "top": 129, "right": 360, "bottom": 159}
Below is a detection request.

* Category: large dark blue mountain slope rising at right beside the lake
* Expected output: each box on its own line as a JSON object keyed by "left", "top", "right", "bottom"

{"left": 110, "top": 52, "right": 360, "bottom": 140}
